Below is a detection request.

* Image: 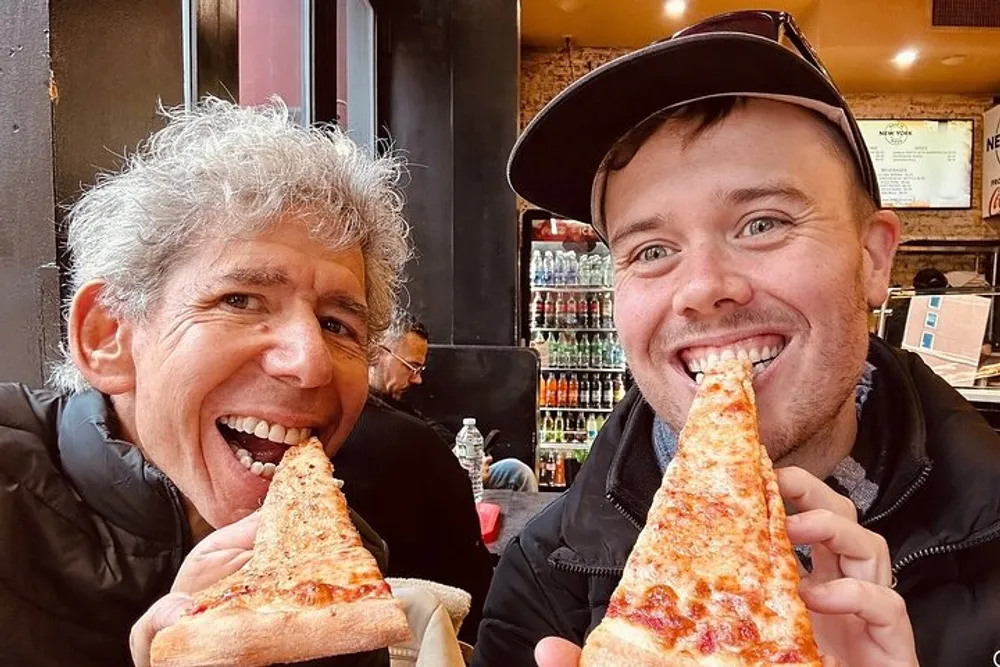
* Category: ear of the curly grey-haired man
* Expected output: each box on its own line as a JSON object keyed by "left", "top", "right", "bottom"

{"left": 69, "top": 280, "right": 135, "bottom": 396}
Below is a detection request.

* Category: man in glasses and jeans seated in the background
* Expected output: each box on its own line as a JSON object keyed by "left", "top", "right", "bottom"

{"left": 368, "top": 311, "right": 538, "bottom": 492}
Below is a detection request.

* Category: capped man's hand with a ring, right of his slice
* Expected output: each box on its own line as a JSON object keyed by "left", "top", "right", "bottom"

{"left": 776, "top": 468, "right": 917, "bottom": 667}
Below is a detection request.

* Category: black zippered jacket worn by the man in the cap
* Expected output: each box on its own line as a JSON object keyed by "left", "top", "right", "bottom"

{"left": 474, "top": 341, "right": 1000, "bottom": 667}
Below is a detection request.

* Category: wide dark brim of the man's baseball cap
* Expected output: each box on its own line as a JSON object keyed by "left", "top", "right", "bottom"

{"left": 507, "top": 33, "right": 846, "bottom": 222}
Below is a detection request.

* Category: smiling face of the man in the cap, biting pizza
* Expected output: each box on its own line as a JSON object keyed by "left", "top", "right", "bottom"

{"left": 605, "top": 100, "right": 899, "bottom": 462}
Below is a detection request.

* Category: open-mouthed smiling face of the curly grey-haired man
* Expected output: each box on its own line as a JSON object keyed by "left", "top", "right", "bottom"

{"left": 112, "top": 211, "right": 368, "bottom": 527}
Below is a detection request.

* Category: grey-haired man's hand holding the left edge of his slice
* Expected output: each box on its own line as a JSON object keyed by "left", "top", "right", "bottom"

{"left": 129, "top": 512, "right": 260, "bottom": 667}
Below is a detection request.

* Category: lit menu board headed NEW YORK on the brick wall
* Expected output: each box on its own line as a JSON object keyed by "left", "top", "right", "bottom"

{"left": 858, "top": 119, "right": 972, "bottom": 208}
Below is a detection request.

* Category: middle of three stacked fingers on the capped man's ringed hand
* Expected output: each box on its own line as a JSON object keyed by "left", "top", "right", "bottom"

{"left": 786, "top": 509, "right": 892, "bottom": 586}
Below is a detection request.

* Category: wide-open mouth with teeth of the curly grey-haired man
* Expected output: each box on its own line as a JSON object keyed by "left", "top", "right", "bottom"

{"left": 216, "top": 415, "right": 311, "bottom": 479}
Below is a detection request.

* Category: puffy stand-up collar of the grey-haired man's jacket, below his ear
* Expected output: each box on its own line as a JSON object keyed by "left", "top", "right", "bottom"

{"left": 59, "top": 391, "right": 191, "bottom": 545}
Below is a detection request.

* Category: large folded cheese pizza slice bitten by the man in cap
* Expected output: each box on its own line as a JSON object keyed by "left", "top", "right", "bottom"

{"left": 580, "top": 360, "right": 820, "bottom": 667}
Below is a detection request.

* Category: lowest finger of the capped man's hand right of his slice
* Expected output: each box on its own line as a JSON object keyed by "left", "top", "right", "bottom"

{"left": 799, "top": 579, "right": 916, "bottom": 664}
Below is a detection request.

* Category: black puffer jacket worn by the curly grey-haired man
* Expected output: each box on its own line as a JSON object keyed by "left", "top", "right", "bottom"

{"left": 0, "top": 384, "right": 389, "bottom": 667}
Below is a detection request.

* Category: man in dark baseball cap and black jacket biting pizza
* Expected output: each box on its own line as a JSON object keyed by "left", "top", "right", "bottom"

{"left": 475, "top": 11, "right": 1000, "bottom": 667}
